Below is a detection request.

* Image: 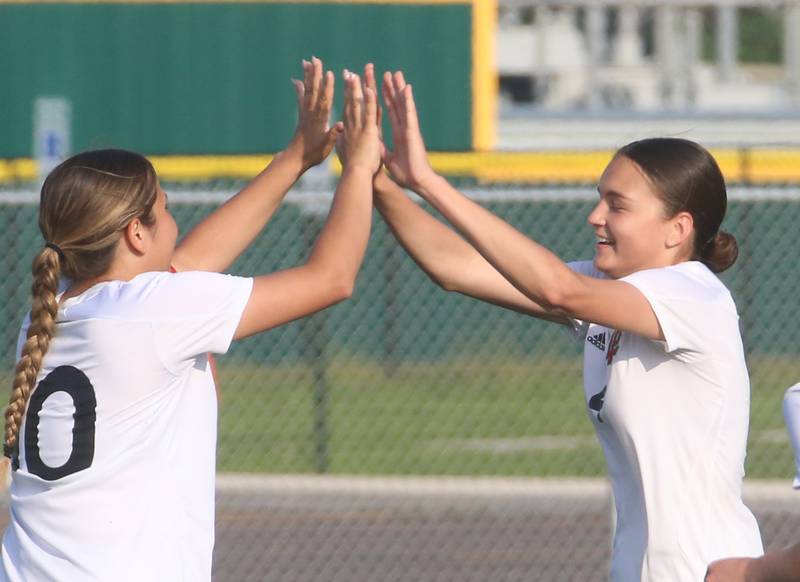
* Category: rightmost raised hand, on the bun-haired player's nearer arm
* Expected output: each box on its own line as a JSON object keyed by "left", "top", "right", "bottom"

{"left": 383, "top": 71, "right": 436, "bottom": 191}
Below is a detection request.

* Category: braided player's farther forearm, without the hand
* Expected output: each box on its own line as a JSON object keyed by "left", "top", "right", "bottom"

{"left": 173, "top": 146, "right": 303, "bottom": 272}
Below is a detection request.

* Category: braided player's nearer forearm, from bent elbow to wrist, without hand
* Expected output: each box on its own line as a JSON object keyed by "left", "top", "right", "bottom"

{"left": 307, "top": 166, "right": 372, "bottom": 289}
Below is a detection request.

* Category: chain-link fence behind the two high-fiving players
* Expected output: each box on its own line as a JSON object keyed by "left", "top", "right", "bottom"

{"left": 0, "top": 183, "right": 800, "bottom": 582}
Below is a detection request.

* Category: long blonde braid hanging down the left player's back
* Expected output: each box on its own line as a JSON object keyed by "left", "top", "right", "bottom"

{"left": 4, "top": 247, "right": 61, "bottom": 457}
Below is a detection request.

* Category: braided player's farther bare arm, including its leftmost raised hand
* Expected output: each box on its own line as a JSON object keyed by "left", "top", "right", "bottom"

{"left": 173, "top": 58, "right": 340, "bottom": 272}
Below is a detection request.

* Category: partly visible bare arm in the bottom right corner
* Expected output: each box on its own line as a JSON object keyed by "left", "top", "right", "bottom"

{"left": 705, "top": 544, "right": 800, "bottom": 582}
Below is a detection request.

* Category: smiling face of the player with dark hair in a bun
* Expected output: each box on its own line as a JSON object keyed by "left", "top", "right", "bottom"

{"left": 588, "top": 155, "right": 692, "bottom": 279}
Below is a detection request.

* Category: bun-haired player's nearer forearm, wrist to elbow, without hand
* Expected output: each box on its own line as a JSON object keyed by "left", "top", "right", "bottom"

{"left": 418, "top": 176, "right": 580, "bottom": 307}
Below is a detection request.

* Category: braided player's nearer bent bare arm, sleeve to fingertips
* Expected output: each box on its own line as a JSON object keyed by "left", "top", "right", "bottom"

{"left": 235, "top": 73, "right": 380, "bottom": 339}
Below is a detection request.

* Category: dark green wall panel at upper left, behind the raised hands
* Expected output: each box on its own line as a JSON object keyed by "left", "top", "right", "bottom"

{"left": 0, "top": 3, "right": 472, "bottom": 158}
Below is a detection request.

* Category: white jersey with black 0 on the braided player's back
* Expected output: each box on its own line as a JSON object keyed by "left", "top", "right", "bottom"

{"left": 0, "top": 273, "right": 252, "bottom": 582}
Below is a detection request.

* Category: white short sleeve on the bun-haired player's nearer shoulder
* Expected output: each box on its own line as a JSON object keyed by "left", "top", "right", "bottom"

{"left": 621, "top": 267, "right": 738, "bottom": 353}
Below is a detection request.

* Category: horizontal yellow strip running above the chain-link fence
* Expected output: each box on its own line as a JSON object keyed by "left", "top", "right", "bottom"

{"left": 0, "top": 149, "right": 800, "bottom": 184}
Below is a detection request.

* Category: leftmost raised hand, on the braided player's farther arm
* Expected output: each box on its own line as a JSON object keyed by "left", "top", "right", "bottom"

{"left": 287, "top": 57, "right": 342, "bottom": 171}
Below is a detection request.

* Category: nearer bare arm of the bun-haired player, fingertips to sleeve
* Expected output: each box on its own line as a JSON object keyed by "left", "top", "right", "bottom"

{"left": 383, "top": 73, "right": 664, "bottom": 340}
